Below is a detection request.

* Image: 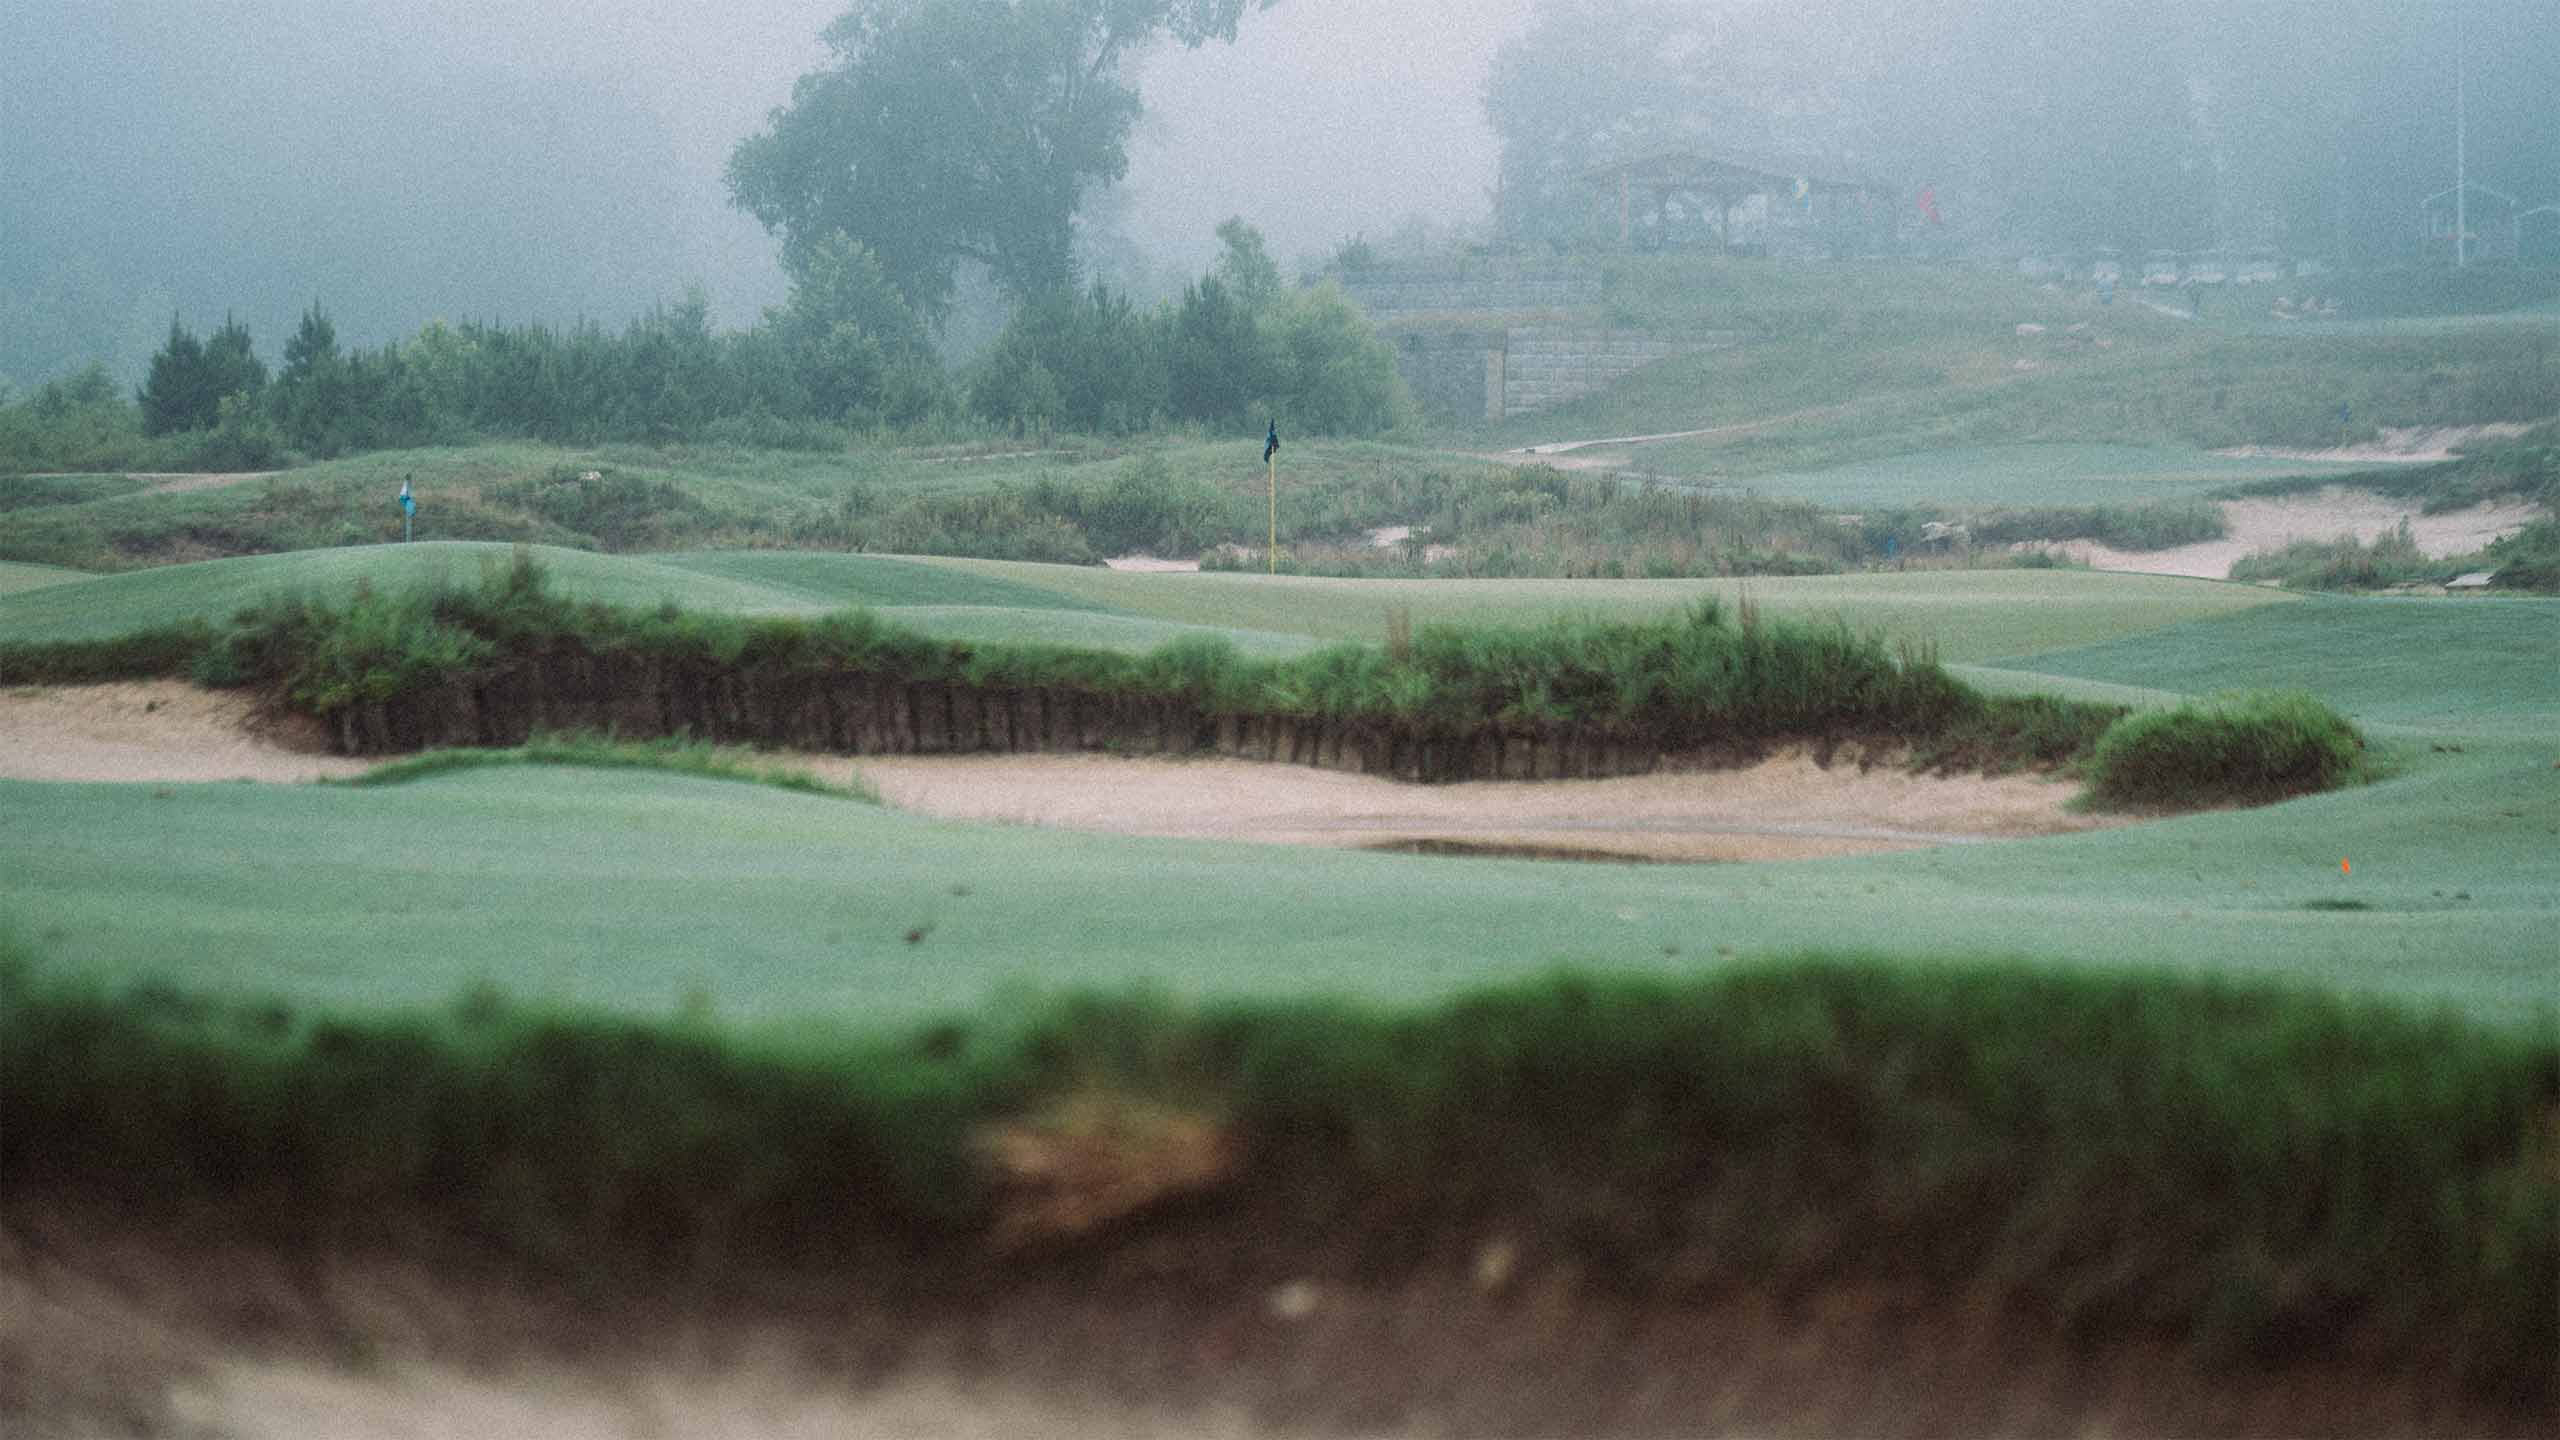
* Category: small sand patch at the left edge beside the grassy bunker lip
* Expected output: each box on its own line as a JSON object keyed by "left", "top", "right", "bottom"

{"left": 0, "top": 679, "right": 366, "bottom": 781}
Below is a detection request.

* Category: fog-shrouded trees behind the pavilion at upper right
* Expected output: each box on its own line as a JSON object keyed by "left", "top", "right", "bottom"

{"left": 1485, "top": 0, "right": 2560, "bottom": 264}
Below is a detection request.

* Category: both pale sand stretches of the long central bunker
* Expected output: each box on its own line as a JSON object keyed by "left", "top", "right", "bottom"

{"left": 0, "top": 682, "right": 2109, "bottom": 861}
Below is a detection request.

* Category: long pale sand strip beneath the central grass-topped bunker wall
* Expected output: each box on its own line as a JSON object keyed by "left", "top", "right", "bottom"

{"left": 812, "top": 751, "right": 2115, "bottom": 861}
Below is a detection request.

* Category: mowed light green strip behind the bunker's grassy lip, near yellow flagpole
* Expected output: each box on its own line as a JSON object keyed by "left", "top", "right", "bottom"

{"left": 0, "top": 541, "right": 2291, "bottom": 661}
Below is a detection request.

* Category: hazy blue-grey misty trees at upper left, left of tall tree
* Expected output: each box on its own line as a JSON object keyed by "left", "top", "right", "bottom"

{"left": 0, "top": 0, "right": 753, "bottom": 387}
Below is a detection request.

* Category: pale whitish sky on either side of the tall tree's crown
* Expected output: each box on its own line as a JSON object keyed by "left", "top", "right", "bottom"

{"left": 285, "top": 0, "right": 1531, "bottom": 297}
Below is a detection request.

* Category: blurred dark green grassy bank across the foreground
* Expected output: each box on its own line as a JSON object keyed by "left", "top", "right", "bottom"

{"left": 0, "top": 940, "right": 2560, "bottom": 1404}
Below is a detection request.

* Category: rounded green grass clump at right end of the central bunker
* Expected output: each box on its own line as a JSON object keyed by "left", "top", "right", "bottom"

{"left": 2089, "top": 689, "right": 2365, "bottom": 805}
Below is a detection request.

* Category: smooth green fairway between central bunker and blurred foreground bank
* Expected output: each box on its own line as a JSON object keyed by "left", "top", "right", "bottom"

{"left": 0, "top": 566, "right": 2560, "bottom": 1022}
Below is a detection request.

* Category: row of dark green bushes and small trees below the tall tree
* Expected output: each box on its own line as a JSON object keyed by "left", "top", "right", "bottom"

{"left": 0, "top": 220, "right": 1411, "bottom": 471}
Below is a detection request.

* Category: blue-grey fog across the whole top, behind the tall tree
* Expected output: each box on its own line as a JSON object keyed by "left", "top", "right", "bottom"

{"left": 0, "top": 0, "right": 2560, "bottom": 387}
